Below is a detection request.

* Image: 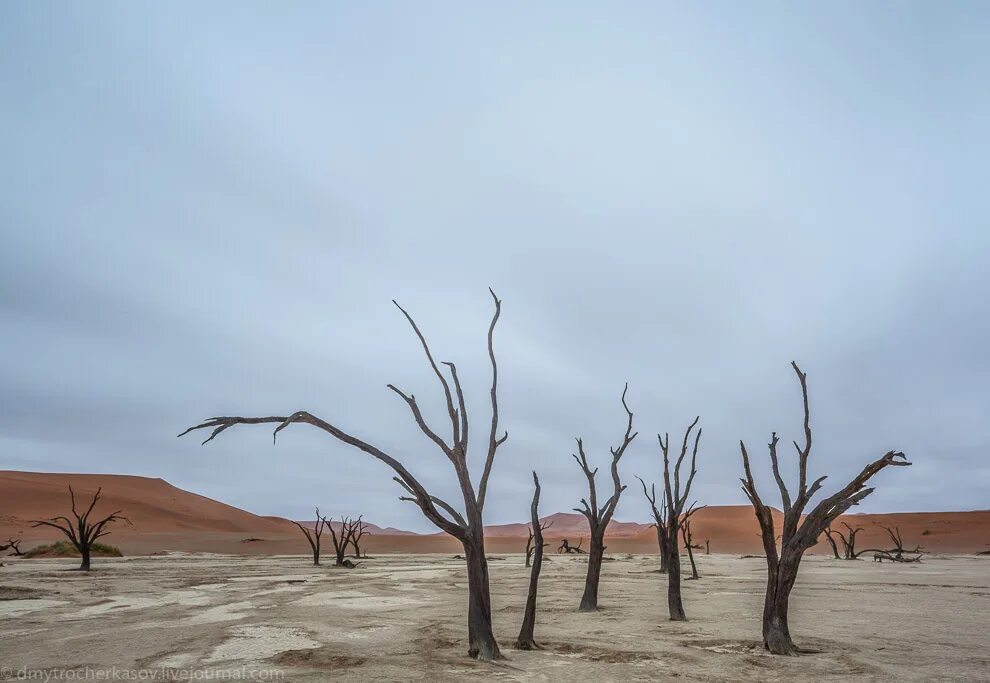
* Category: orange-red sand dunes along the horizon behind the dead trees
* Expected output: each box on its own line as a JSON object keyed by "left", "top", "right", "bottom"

{"left": 0, "top": 471, "right": 990, "bottom": 555}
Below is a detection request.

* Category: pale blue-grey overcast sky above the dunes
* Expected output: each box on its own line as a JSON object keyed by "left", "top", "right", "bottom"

{"left": 0, "top": 2, "right": 990, "bottom": 531}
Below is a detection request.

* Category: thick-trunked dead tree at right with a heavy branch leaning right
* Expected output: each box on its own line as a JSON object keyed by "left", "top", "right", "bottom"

{"left": 739, "top": 363, "right": 911, "bottom": 655}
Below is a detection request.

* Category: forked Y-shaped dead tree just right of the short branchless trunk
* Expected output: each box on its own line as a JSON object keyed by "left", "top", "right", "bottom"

{"left": 573, "top": 384, "right": 636, "bottom": 612}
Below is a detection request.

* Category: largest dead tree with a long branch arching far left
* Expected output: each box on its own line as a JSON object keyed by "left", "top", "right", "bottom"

{"left": 180, "top": 290, "right": 508, "bottom": 660}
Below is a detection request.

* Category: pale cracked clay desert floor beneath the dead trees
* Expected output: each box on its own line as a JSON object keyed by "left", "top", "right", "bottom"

{"left": 0, "top": 554, "right": 990, "bottom": 681}
